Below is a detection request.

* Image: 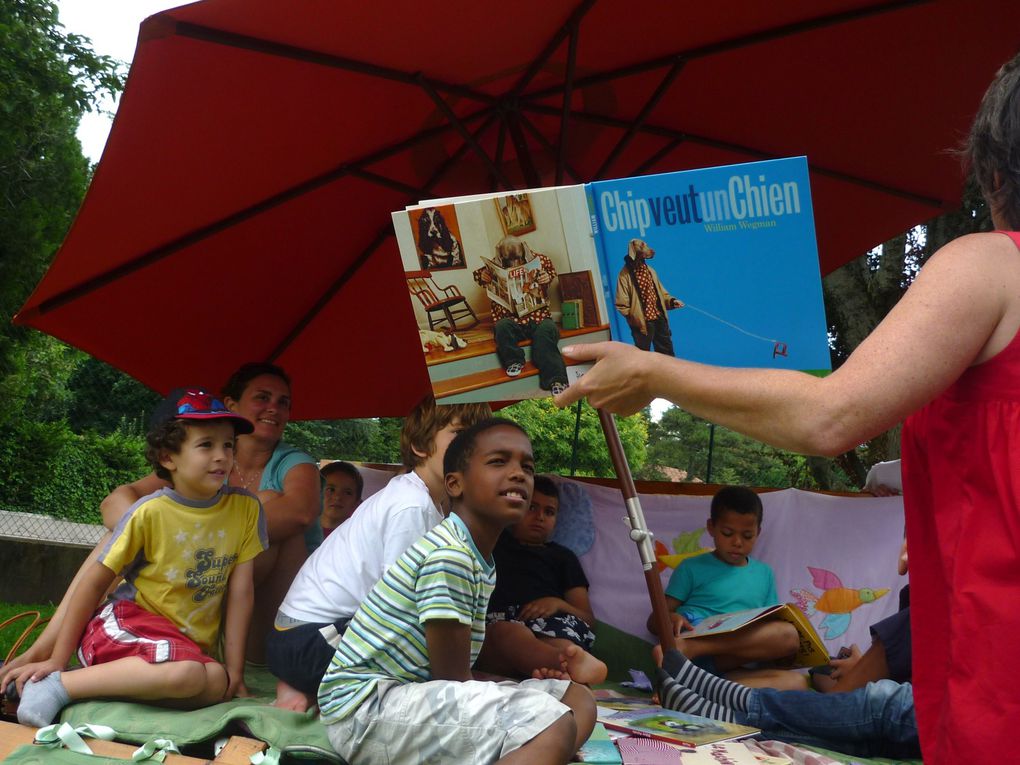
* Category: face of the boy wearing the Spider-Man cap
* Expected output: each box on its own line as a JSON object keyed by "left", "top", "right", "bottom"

{"left": 159, "top": 420, "right": 234, "bottom": 500}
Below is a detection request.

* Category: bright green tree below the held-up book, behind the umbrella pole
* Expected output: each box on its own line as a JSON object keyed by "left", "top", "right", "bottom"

{"left": 498, "top": 398, "right": 648, "bottom": 477}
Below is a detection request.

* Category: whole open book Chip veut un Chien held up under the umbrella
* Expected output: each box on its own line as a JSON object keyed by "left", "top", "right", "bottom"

{"left": 392, "top": 157, "right": 829, "bottom": 404}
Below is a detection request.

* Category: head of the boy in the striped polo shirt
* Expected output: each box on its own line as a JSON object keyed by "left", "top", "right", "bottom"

{"left": 447, "top": 425, "right": 534, "bottom": 528}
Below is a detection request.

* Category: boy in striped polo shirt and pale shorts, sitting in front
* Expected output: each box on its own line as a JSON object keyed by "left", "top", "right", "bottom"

{"left": 318, "top": 419, "right": 595, "bottom": 765}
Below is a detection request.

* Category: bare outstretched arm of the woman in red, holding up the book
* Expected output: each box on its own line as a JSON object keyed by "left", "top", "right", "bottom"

{"left": 556, "top": 234, "right": 1020, "bottom": 455}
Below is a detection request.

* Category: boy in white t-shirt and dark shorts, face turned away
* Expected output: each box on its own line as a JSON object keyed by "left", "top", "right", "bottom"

{"left": 266, "top": 396, "right": 492, "bottom": 712}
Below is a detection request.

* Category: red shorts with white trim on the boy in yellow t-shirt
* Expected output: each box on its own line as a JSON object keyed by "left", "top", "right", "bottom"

{"left": 78, "top": 601, "right": 216, "bottom": 667}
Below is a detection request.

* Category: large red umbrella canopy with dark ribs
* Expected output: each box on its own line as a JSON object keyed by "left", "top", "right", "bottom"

{"left": 16, "top": 0, "right": 1020, "bottom": 418}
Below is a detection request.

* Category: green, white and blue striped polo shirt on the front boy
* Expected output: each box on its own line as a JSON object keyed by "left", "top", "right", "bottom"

{"left": 318, "top": 514, "right": 496, "bottom": 724}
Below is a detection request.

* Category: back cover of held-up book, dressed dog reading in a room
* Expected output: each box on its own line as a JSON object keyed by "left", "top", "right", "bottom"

{"left": 393, "top": 187, "right": 610, "bottom": 404}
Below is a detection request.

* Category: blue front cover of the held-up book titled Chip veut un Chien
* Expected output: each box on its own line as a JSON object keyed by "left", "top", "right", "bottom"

{"left": 585, "top": 157, "right": 830, "bottom": 373}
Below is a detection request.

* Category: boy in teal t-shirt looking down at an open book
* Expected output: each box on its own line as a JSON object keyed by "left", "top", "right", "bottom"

{"left": 649, "top": 487, "right": 805, "bottom": 689}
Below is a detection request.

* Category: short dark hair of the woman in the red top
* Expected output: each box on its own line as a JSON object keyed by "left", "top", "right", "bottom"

{"left": 963, "top": 55, "right": 1020, "bottom": 231}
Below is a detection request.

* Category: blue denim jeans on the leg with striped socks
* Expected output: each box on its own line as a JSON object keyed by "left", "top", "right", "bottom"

{"left": 736, "top": 680, "right": 921, "bottom": 759}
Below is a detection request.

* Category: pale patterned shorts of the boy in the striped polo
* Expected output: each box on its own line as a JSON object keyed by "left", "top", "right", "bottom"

{"left": 325, "top": 680, "right": 570, "bottom": 765}
